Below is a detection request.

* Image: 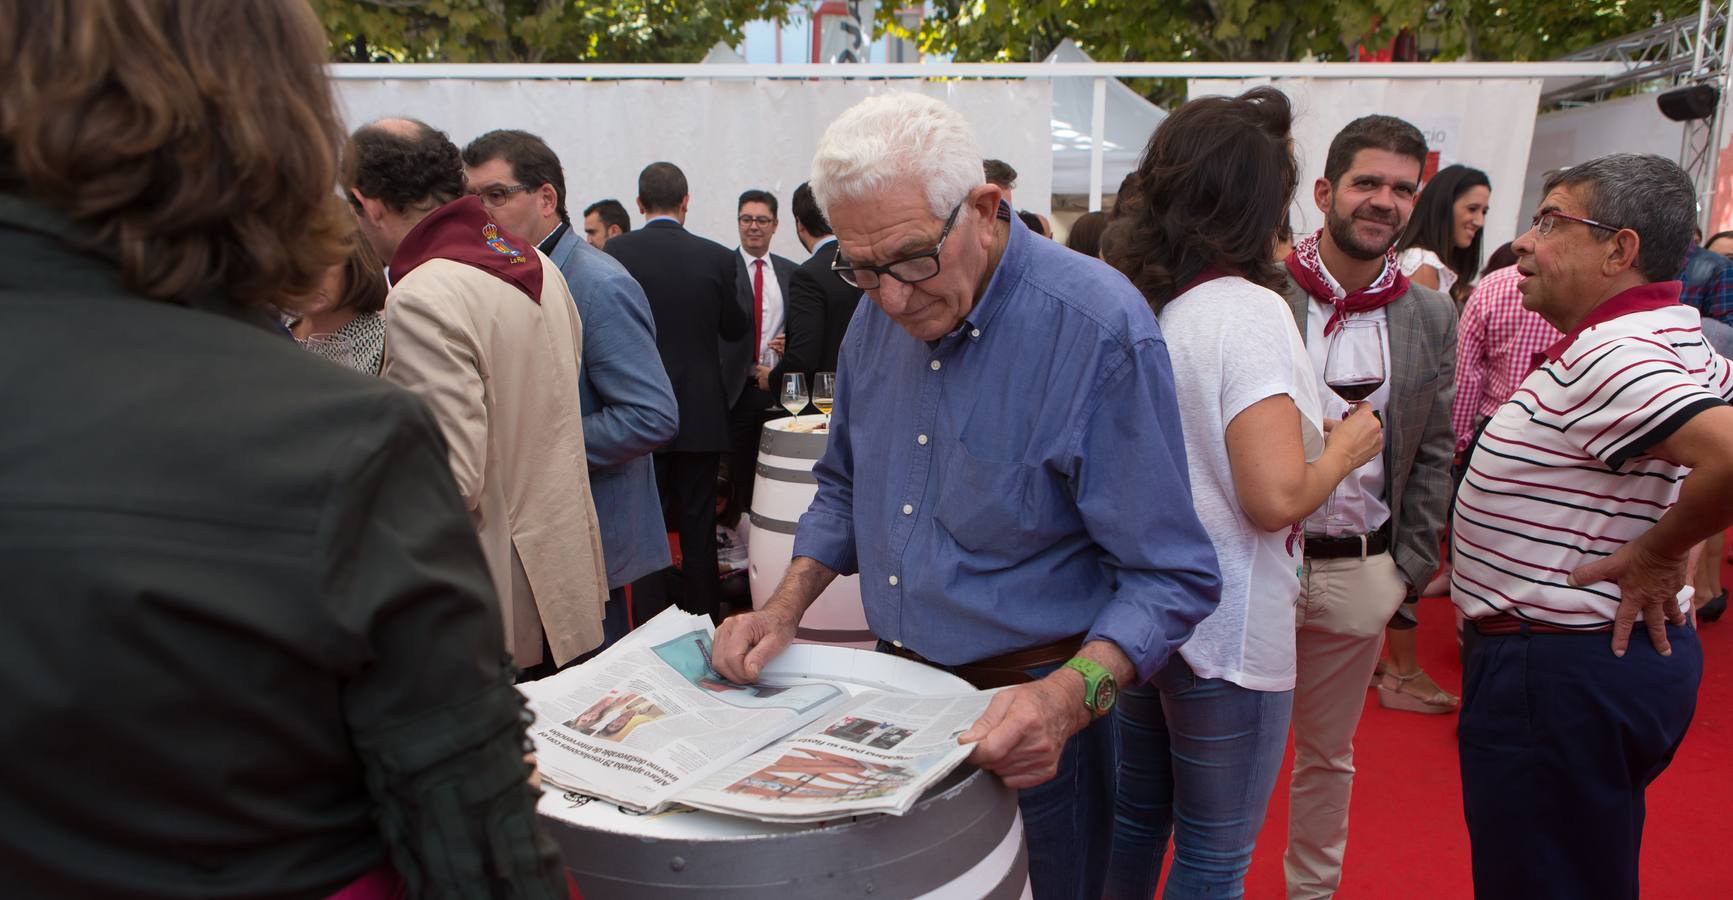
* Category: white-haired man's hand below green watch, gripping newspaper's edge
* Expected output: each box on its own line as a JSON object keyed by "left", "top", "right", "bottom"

{"left": 957, "top": 683, "right": 1090, "bottom": 789}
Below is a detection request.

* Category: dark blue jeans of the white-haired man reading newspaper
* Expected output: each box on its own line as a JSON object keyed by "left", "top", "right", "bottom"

{"left": 879, "top": 652, "right": 1120, "bottom": 900}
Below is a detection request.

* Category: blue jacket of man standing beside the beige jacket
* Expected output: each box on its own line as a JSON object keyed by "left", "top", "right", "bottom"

{"left": 544, "top": 225, "right": 679, "bottom": 590}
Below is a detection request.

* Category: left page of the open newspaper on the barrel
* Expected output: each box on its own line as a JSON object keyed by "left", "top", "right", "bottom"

{"left": 518, "top": 609, "right": 847, "bottom": 812}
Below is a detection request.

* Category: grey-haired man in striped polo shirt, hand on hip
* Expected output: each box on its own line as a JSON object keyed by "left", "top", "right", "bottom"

{"left": 1451, "top": 154, "right": 1733, "bottom": 900}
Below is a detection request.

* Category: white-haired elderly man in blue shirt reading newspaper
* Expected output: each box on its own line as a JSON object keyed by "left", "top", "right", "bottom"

{"left": 716, "top": 94, "right": 1220, "bottom": 900}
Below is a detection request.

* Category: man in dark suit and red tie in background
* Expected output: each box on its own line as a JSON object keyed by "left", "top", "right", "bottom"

{"left": 721, "top": 191, "right": 793, "bottom": 510}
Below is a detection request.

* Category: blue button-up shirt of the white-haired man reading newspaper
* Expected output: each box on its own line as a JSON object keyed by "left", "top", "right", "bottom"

{"left": 794, "top": 211, "right": 1220, "bottom": 678}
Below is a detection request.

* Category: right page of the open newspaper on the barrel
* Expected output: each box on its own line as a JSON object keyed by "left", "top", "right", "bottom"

{"left": 678, "top": 690, "right": 993, "bottom": 822}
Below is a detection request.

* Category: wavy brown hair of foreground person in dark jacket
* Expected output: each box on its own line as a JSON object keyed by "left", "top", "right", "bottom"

{"left": 0, "top": 0, "right": 347, "bottom": 307}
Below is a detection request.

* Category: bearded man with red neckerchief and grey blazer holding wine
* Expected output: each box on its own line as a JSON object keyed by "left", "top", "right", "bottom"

{"left": 1282, "top": 116, "right": 1456, "bottom": 898}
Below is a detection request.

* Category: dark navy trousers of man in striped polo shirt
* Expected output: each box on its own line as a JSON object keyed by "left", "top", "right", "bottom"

{"left": 1456, "top": 624, "right": 1704, "bottom": 900}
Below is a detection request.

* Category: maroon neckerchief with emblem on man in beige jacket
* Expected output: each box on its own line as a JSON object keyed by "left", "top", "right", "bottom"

{"left": 386, "top": 194, "right": 542, "bottom": 303}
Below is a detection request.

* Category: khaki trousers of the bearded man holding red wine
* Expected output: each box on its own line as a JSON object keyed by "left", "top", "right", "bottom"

{"left": 1282, "top": 553, "right": 1407, "bottom": 900}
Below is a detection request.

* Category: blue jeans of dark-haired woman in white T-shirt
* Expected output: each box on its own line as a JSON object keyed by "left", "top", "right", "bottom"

{"left": 1104, "top": 654, "right": 1293, "bottom": 900}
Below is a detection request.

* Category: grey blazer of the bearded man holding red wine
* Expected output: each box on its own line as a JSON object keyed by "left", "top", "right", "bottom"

{"left": 1282, "top": 272, "right": 1456, "bottom": 597}
